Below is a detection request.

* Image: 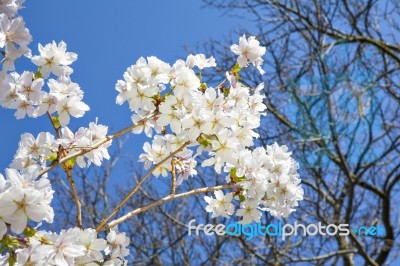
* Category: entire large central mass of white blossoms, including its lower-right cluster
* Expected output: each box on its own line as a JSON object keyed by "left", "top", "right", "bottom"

{"left": 116, "top": 36, "right": 303, "bottom": 223}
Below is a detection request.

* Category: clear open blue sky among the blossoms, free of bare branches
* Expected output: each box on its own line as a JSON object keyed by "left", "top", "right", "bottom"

{"left": 0, "top": 0, "right": 252, "bottom": 170}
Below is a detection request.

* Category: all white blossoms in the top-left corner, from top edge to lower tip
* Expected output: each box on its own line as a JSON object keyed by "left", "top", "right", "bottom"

{"left": 0, "top": 0, "right": 89, "bottom": 127}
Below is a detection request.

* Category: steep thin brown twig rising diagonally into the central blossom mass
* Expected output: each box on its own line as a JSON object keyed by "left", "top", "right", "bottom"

{"left": 96, "top": 141, "right": 190, "bottom": 232}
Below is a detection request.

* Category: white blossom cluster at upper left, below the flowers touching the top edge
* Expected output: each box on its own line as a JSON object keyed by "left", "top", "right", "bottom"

{"left": 0, "top": 42, "right": 89, "bottom": 124}
